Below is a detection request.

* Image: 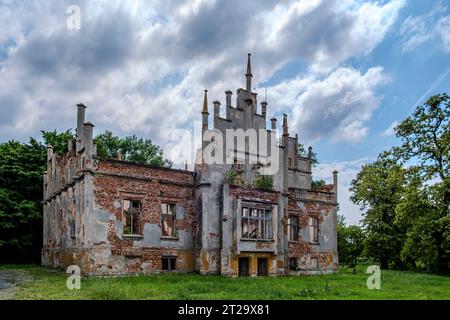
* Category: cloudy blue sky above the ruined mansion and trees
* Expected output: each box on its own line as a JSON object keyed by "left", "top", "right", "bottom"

{"left": 0, "top": 0, "right": 450, "bottom": 224}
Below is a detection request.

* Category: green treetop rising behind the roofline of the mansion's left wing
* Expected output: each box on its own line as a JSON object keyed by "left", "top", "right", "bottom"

{"left": 95, "top": 131, "right": 172, "bottom": 167}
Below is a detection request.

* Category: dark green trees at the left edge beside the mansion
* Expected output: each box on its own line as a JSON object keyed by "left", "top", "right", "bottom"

{"left": 0, "top": 131, "right": 72, "bottom": 263}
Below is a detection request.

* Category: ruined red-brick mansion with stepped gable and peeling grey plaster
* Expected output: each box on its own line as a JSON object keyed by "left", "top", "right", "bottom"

{"left": 42, "top": 55, "right": 338, "bottom": 277}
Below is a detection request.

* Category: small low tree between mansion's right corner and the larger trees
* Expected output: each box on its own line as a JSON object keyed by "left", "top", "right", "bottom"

{"left": 337, "top": 215, "right": 365, "bottom": 266}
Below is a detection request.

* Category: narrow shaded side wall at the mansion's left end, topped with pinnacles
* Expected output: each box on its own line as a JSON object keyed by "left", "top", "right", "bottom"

{"left": 41, "top": 124, "right": 96, "bottom": 271}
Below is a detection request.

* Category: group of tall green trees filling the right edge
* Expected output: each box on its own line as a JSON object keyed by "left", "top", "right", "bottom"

{"left": 350, "top": 94, "right": 450, "bottom": 273}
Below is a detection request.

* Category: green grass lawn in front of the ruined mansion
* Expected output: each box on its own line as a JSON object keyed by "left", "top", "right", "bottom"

{"left": 0, "top": 265, "right": 450, "bottom": 300}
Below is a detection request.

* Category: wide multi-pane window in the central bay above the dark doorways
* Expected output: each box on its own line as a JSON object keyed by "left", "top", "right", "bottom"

{"left": 241, "top": 207, "right": 273, "bottom": 240}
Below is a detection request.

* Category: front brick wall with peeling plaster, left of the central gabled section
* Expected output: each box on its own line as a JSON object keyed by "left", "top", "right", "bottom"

{"left": 90, "top": 160, "right": 196, "bottom": 274}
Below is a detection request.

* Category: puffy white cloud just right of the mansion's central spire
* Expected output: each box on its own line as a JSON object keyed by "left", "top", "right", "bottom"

{"left": 269, "top": 67, "right": 388, "bottom": 142}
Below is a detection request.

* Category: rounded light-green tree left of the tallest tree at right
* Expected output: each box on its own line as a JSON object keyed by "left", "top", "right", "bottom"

{"left": 350, "top": 154, "right": 405, "bottom": 269}
